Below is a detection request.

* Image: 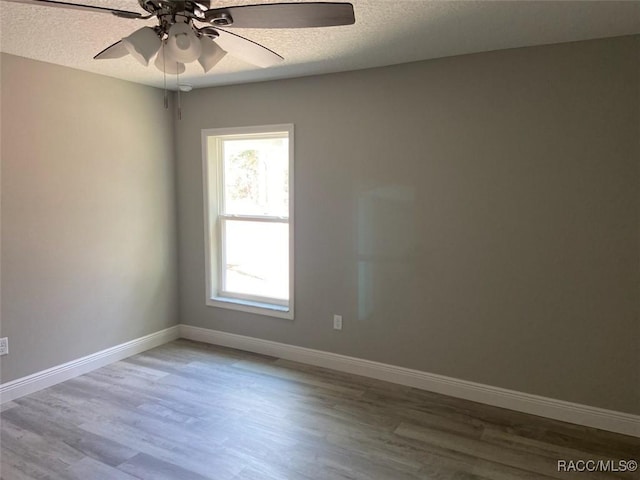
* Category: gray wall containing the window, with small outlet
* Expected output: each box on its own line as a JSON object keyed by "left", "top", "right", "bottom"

{"left": 177, "top": 37, "right": 640, "bottom": 413}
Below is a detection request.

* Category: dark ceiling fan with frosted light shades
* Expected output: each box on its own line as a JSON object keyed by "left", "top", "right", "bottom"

{"left": 4, "top": 0, "right": 355, "bottom": 74}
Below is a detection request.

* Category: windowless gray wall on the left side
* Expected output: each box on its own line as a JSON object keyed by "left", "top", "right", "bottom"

{"left": 0, "top": 54, "right": 177, "bottom": 382}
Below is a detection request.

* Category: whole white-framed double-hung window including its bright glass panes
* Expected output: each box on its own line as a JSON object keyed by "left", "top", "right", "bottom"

{"left": 202, "top": 125, "right": 293, "bottom": 319}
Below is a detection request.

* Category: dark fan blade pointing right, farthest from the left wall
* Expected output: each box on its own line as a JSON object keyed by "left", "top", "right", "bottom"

{"left": 204, "top": 2, "right": 356, "bottom": 28}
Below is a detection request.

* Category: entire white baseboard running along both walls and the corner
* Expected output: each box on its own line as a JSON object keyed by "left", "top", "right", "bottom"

{"left": 0, "top": 325, "right": 640, "bottom": 437}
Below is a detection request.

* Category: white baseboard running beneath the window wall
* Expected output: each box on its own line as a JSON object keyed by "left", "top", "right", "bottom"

{"left": 179, "top": 325, "right": 640, "bottom": 437}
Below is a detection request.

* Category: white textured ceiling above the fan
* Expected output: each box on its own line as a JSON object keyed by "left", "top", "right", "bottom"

{"left": 0, "top": 0, "right": 640, "bottom": 88}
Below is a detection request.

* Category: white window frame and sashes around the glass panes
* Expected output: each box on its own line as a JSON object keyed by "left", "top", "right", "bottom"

{"left": 202, "top": 124, "right": 295, "bottom": 320}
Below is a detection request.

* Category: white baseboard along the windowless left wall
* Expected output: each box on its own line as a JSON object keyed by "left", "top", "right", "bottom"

{"left": 0, "top": 325, "right": 180, "bottom": 404}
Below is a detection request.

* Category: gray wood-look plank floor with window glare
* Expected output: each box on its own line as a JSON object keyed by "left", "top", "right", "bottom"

{"left": 0, "top": 340, "right": 640, "bottom": 480}
